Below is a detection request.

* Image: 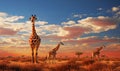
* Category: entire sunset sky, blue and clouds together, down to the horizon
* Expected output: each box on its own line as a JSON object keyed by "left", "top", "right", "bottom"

{"left": 0, "top": 0, "right": 120, "bottom": 57}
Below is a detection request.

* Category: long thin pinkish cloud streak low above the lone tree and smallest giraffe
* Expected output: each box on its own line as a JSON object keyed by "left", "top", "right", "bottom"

{"left": 62, "top": 36, "right": 120, "bottom": 45}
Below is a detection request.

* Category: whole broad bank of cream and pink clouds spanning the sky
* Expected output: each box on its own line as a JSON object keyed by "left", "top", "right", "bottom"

{"left": 0, "top": 12, "right": 119, "bottom": 51}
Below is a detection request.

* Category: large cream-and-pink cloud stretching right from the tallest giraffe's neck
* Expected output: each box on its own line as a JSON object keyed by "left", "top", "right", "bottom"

{"left": 39, "top": 16, "right": 117, "bottom": 41}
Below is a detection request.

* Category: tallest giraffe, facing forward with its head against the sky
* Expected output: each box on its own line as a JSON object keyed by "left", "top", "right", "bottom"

{"left": 29, "top": 15, "right": 41, "bottom": 63}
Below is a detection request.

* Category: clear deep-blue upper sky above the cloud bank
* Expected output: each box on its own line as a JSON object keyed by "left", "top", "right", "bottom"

{"left": 0, "top": 0, "right": 120, "bottom": 24}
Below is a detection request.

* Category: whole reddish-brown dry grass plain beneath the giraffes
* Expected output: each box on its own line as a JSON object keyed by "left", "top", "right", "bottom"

{"left": 0, "top": 57, "right": 120, "bottom": 71}
